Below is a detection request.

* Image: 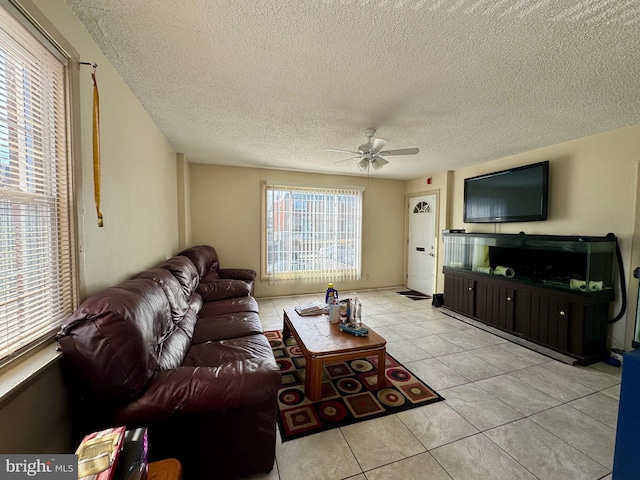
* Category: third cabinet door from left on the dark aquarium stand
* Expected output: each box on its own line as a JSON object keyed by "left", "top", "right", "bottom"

{"left": 513, "top": 291, "right": 571, "bottom": 351}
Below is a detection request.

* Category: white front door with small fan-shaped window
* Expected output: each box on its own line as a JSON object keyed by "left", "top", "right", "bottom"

{"left": 407, "top": 194, "right": 437, "bottom": 295}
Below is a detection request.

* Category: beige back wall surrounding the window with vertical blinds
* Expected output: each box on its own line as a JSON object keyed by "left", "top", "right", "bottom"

{"left": 191, "top": 164, "right": 405, "bottom": 297}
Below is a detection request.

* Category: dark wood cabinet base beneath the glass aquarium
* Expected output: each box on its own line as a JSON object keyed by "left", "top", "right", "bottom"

{"left": 443, "top": 267, "right": 613, "bottom": 365}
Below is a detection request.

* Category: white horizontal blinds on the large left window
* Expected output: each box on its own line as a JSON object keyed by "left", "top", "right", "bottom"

{"left": 0, "top": 2, "right": 75, "bottom": 363}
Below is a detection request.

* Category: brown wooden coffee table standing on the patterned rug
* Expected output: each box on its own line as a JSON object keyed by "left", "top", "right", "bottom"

{"left": 282, "top": 307, "right": 387, "bottom": 401}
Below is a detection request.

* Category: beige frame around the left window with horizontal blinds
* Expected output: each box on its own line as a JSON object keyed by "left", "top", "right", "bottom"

{"left": 0, "top": 0, "right": 84, "bottom": 373}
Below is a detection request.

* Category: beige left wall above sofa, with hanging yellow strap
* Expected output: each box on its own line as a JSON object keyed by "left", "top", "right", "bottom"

{"left": 34, "top": 0, "right": 178, "bottom": 296}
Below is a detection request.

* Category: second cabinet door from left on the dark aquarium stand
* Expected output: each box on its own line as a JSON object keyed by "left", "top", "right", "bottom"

{"left": 476, "top": 281, "right": 515, "bottom": 331}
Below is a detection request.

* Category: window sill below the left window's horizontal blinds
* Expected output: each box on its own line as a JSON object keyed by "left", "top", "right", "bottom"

{"left": 0, "top": 341, "right": 61, "bottom": 408}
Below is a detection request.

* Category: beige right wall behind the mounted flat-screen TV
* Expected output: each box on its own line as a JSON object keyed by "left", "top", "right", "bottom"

{"left": 407, "top": 125, "right": 640, "bottom": 348}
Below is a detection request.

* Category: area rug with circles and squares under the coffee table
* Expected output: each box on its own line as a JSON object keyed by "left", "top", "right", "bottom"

{"left": 265, "top": 331, "right": 444, "bottom": 442}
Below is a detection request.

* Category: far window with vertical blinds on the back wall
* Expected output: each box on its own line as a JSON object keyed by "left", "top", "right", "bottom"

{"left": 262, "top": 182, "right": 362, "bottom": 282}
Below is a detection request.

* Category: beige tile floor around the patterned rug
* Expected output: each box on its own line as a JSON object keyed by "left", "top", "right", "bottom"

{"left": 251, "top": 288, "right": 621, "bottom": 480}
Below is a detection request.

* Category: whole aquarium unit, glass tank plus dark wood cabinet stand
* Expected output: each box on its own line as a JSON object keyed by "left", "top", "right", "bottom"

{"left": 443, "top": 234, "right": 615, "bottom": 365}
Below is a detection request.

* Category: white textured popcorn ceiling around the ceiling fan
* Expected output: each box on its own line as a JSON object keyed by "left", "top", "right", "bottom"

{"left": 67, "top": 0, "right": 640, "bottom": 179}
